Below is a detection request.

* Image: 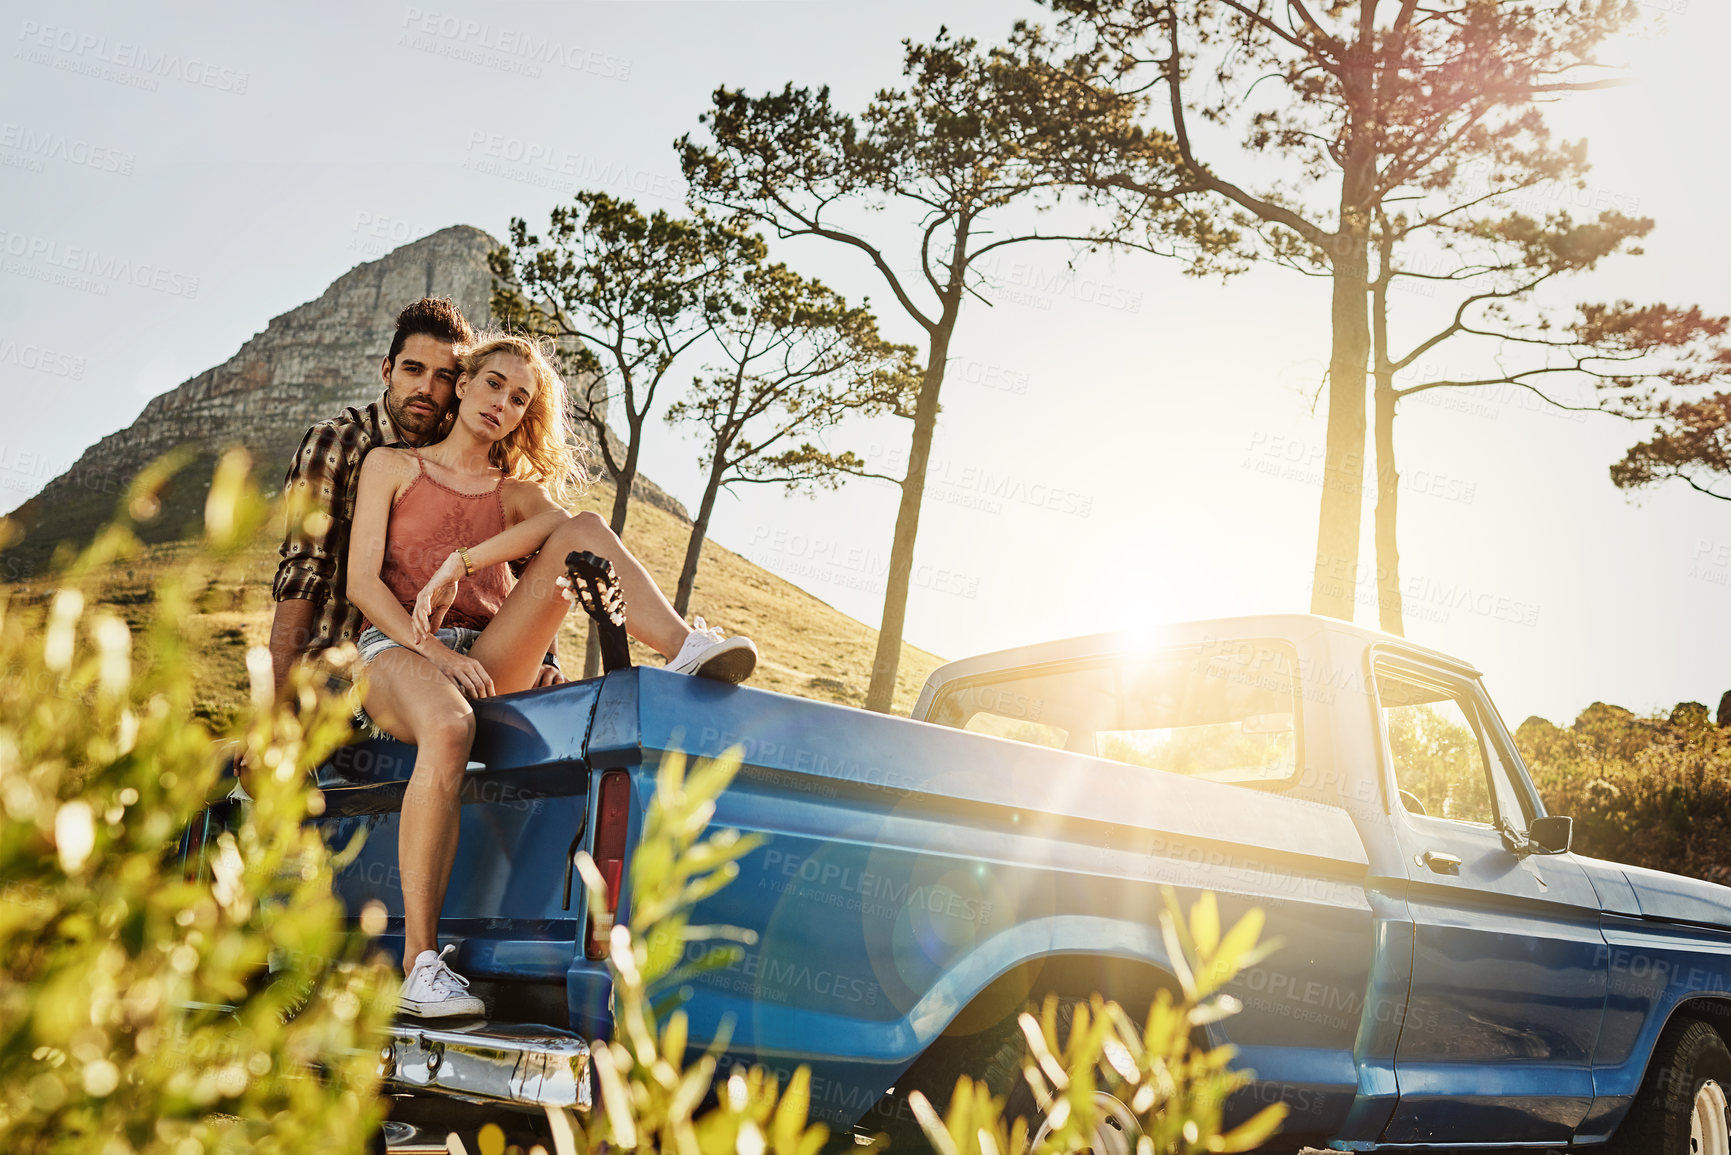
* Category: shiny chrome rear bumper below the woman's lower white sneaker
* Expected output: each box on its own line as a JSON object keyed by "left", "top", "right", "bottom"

{"left": 379, "top": 1022, "right": 590, "bottom": 1112}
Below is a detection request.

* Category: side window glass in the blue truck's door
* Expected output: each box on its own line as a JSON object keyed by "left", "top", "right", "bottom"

{"left": 1376, "top": 663, "right": 1494, "bottom": 826}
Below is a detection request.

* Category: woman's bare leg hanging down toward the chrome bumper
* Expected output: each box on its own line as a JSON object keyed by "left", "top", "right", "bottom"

{"left": 365, "top": 649, "right": 474, "bottom": 975}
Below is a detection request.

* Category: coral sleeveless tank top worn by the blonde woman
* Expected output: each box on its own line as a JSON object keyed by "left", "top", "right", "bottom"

{"left": 379, "top": 450, "right": 514, "bottom": 630}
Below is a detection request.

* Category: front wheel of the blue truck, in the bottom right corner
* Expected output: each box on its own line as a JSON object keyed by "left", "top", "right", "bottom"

{"left": 1606, "top": 1018, "right": 1731, "bottom": 1155}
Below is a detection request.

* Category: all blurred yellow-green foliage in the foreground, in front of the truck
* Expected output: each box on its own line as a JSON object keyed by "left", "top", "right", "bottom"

{"left": 0, "top": 454, "right": 1284, "bottom": 1155}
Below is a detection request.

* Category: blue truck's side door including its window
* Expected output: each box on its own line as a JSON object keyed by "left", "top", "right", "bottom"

{"left": 1373, "top": 655, "right": 1606, "bottom": 1143}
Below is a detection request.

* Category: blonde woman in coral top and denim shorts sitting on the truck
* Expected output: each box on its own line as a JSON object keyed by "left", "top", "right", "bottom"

{"left": 348, "top": 336, "right": 756, "bottom": 1016}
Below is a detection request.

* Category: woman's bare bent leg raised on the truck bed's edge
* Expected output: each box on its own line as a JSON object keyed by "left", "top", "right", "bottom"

{"left": 469, "top": 511, "right": 691, "bottom": 694}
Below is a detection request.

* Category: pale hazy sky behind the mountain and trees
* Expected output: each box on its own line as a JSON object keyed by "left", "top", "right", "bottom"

{"left": 0, "top": 0, "right": 1731, "bottom": 724}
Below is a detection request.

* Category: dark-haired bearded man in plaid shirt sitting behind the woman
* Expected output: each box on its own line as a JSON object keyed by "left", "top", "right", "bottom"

{"left": 270, "top": 296, "right": 564, "bottom": 694}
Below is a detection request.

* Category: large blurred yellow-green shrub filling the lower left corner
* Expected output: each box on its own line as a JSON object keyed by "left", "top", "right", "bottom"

{"left": 0, "top": 455, "right": 395, "bottom": 1155}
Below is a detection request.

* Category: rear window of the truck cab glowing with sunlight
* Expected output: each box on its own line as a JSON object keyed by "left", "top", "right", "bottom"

{"left": 930, "top": 639, "right": 1300, "bottom": 784}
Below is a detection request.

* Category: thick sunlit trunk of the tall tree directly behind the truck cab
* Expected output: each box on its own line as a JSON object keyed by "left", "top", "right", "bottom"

{"left": 1310, "top": 218, "right": 1371, "bottom": 622}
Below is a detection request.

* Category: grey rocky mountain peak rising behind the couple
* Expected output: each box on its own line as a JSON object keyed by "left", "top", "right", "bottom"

{"left": 0, "top": 225, "right": 685, "bottom": 580}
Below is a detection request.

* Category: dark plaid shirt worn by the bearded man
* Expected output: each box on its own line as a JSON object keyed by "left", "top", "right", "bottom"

{"left": 270, "top": 397, "right": 398, "bottom": 655}
